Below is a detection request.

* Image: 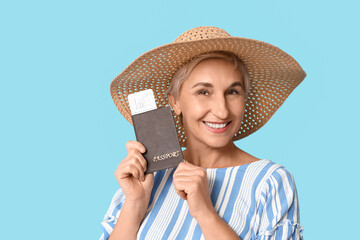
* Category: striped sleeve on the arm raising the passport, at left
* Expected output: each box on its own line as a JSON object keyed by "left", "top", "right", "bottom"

{"left": 100, "top": 189, "right": 125, "bottom": 240}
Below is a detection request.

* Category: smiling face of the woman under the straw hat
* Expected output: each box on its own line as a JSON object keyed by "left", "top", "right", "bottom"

{"left": 169, "top": 59, "right": 245, "bottom": 148}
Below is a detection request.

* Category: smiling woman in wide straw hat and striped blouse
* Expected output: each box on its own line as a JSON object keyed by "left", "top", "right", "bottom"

{"left": 102, "top": 27, "right": 305, "bottom": 239}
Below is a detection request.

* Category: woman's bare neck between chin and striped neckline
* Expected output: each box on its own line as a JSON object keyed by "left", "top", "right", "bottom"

{"left": 184, "top": 142, "right": 244, "bottom": 168}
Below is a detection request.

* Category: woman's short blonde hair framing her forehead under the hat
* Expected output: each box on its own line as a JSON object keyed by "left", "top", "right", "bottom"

{"left": 166, "top": 51, "right": 250, "bottom": 101}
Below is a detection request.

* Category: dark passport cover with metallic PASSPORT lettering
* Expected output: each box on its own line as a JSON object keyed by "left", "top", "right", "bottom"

{"left": 132, "top": 107, "right": 184, "bottom": 173}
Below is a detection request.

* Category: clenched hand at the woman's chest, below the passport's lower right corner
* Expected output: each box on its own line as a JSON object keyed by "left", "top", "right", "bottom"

{"left": 173, "top": 162, "right": 217, "bottom": 220}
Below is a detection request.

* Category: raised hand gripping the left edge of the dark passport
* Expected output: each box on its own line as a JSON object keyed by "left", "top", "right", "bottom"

{"left": 115, "top": 141, "right": 154, "bottom": 204}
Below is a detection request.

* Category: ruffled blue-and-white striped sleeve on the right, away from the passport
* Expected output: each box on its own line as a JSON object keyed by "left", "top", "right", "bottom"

{"left": 256, "top": 167, "right": 303, "bottom": 240}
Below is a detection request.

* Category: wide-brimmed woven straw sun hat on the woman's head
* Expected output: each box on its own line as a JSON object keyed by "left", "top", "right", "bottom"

{"left": 110, "top": 27, "right": 306, "bottom": 147}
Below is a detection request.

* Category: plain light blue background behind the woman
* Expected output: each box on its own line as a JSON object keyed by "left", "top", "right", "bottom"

{"left": 0, "top": 0, "right": 360, "bottom": 239}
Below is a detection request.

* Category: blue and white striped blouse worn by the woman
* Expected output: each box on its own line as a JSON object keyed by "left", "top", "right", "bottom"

{"left": 100, "top": 159, "right": 303, "bottom": 240}
